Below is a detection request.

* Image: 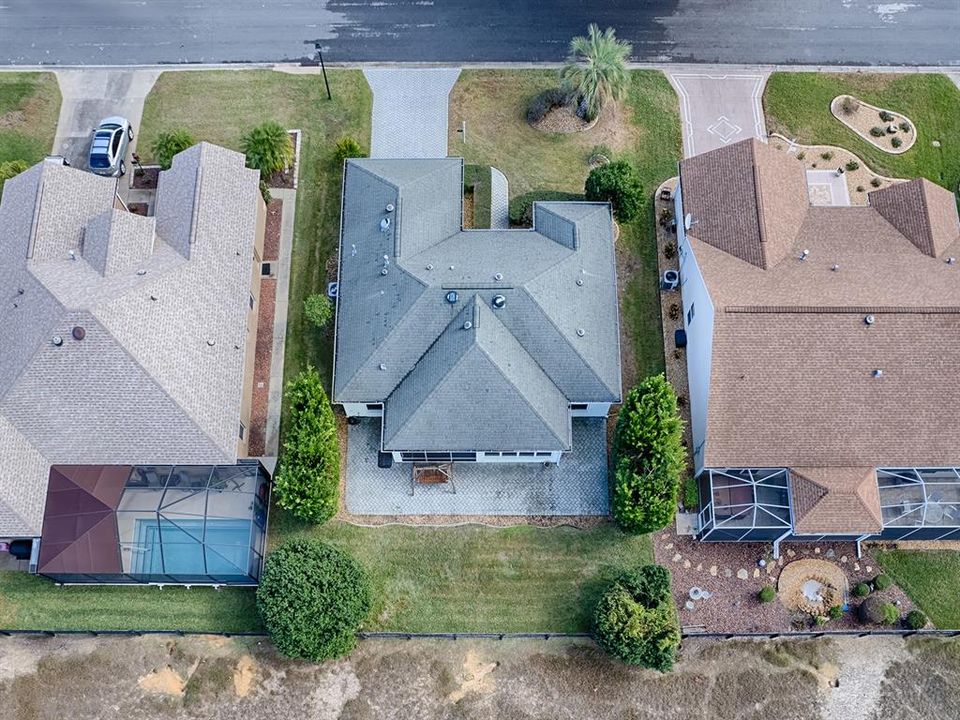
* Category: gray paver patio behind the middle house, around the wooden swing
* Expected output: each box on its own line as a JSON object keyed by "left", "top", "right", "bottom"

{"left": 346, "top": 418, "right": 609, "bottom": 516}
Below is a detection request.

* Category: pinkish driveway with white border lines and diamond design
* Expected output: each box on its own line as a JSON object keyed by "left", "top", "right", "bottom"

{"left": 667, "top": 72, "right": 769, "bottom": 157}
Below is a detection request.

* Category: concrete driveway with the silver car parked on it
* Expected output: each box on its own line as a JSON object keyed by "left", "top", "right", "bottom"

{"left": 53, "top": 69, "right": 160, "bottom": 201}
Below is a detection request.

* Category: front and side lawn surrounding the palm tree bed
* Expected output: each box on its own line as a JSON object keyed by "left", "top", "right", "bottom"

{"left": 448, "top": 70, "right": 681, "bottom": 378}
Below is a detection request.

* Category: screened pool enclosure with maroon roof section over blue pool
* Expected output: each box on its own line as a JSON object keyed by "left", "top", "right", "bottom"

{"left": 37, "top": 461, "right": 269, "bottom": 585}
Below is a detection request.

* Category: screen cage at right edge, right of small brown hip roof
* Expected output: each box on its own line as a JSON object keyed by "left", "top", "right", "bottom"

{"left": 877, "top": 467, "right": 960, "bottom": 540}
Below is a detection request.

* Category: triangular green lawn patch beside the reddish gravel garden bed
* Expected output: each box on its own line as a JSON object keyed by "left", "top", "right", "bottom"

{"left": 873, "top": 550, "right": 960, "bottom": 629}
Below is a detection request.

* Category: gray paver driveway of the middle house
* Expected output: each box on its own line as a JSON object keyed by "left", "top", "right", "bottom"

{"left": 363, "top": 68, "right": 460, "bottom": 158}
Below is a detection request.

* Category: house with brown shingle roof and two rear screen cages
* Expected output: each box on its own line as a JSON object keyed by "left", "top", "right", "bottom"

{"left": 676, "top": 140, "right": 960, "bottom": 540}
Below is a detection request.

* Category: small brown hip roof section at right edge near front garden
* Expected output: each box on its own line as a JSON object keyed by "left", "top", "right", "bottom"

{"left": 867, "top": 178, "right": 960, "bottom": 257}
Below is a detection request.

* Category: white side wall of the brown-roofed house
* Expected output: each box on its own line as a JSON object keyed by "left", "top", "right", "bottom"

{"left": 675, "top": 188, "right": 714, "bottom": 473}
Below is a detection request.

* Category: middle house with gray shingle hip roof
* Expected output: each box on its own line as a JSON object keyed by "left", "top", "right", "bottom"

{"left": 333, "top": 158, "right": 621, "bottom": 462}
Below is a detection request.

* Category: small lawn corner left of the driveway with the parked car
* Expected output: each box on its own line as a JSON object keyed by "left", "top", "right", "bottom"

{"left": 0, "top": 72, "right": 60, "bottom": 165}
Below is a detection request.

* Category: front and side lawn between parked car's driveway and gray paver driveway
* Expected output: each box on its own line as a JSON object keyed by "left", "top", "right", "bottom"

{"left": 138, "top": 70, "right": 372, "bottom": 390}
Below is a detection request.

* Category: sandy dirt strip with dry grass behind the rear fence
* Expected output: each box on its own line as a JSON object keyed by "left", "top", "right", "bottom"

{"left": 0, "top": 636, "right": 960, "bottom": 720}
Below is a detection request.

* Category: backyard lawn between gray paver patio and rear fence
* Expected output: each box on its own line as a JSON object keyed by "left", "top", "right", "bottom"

{"left": 271, "top": 512, "right": 653, "bottom": 632}
